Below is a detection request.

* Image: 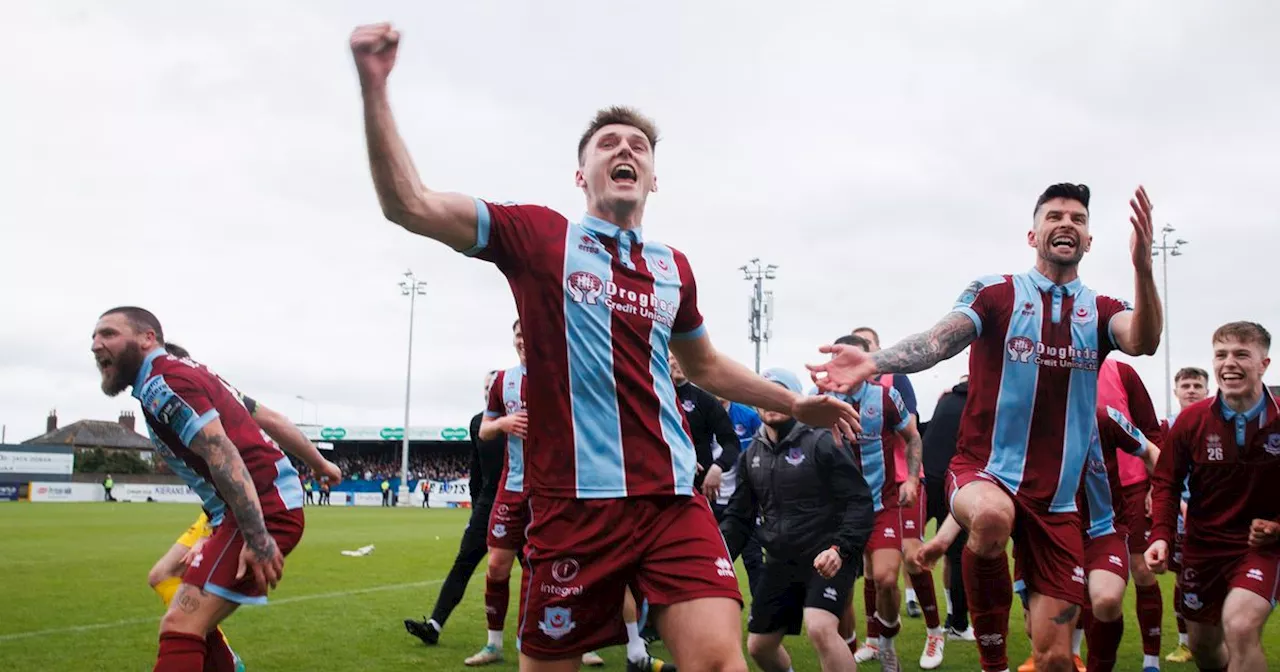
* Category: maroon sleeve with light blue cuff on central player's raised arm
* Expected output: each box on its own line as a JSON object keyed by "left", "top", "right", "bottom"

{"left": 462, "top": 198, "right": 568, "bottom": 273}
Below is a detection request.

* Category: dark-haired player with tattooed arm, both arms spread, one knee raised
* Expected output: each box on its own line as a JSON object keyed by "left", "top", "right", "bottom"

{"left": 810, "top": 184, "right": 1161, "bottom": 672}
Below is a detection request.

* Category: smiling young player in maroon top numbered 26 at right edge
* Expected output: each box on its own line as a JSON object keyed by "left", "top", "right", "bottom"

{"left": 1147, "top": 321, "right": 1280, "bottom": 672}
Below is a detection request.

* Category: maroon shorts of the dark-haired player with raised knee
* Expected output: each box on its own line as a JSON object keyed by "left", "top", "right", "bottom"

{"left": 947, "top": 468, "right": 1085, "bottom": 607}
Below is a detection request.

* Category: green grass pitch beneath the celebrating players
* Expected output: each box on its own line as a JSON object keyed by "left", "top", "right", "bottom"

{"left": 0, "top": 503, "right": 1280, "bottom": 672}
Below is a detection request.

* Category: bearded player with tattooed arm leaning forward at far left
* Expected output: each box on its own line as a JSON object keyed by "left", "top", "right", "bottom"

{"left": 92, "top": 307, "right": 303, "bottom": 672}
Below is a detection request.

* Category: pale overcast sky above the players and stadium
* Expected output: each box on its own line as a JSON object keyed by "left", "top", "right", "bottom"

{"left": 0, "top": 0, "right": 1280, "bottom": 442}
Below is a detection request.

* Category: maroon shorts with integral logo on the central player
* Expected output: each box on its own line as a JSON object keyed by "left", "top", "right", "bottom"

{"left": 517, "top": 494, "right": 742, "bottom": 660}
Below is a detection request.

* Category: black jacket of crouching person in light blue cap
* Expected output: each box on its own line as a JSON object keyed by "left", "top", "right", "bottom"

{"left": 721, "top": 422, "right": 876, "bottom": 567}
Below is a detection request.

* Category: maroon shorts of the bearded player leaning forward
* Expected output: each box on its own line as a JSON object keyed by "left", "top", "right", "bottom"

{"left": 182, "top": 508, "right": 305, "bottom": 604}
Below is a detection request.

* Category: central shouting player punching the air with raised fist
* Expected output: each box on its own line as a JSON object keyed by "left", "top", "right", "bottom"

{"left": 351, "top": 23, "right": 856, "bottom": 671}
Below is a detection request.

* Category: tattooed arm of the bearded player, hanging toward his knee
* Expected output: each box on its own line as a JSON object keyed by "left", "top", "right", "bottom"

{"left": 189, "top": 419, "right": 284, "bottom": 588}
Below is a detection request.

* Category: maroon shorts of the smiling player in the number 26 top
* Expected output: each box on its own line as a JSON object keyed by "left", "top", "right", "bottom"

{"left": 1181, "top": 548, "right": 1280, "bottom": 623}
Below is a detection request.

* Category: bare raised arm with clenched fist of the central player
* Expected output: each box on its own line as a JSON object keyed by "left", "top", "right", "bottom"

{"left": 351, "top": 23, "right": 479, "bottom": 252}
